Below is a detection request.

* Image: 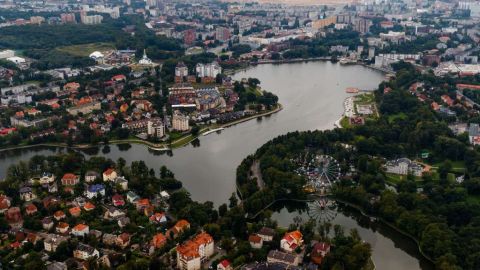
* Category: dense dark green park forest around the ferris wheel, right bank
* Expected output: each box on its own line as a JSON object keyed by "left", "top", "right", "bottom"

{"left": 237, "top": 63, "right": 480, "bottom": 270}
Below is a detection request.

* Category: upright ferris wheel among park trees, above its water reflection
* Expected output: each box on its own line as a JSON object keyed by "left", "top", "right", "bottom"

{"left": 310, "top": 155, "right": 341, "bottom": 190}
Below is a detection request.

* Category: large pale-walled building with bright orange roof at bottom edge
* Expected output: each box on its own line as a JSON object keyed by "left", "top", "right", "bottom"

{"left": 177, "top": 233, "right": 214, "bottom": 270}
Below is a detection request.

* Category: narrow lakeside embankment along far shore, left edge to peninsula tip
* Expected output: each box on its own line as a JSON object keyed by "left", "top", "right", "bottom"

{"left": 0, "top": 103, "right": 283, "bottom": 152}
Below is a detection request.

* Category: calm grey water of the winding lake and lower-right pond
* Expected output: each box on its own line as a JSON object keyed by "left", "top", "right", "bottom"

{"left": 0, "top": 62, "right": 436, "bottom": 270}
